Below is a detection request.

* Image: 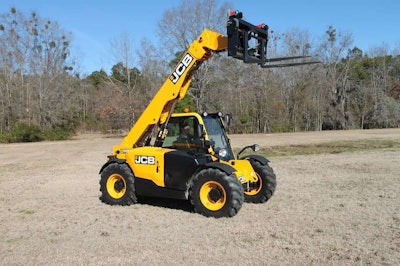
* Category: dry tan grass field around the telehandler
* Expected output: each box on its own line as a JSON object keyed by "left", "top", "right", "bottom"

{"left": 0, "top": 129, "right": 400, "bottom": 265}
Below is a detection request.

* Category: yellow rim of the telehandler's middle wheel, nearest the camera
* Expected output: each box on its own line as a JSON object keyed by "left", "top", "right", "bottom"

{"left": 200, "top": 181, "right": 226, "bottom": 211}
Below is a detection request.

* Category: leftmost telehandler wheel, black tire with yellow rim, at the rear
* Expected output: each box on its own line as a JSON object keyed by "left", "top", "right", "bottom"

{"left": 100, "top": 163, "right": 137, "bottom": 205}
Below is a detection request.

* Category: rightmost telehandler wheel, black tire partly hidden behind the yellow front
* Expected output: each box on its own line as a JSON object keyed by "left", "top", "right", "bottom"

{"left": 244, "top": 160, "right": 276, "bottom": 203}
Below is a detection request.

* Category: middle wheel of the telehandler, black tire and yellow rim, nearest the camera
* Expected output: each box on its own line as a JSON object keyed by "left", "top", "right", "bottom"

{"left": 189, "top": 168, "right": 244, "bottom": 218}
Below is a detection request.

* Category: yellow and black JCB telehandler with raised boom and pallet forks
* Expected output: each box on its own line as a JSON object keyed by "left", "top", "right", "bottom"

{"left": 100, "top": 12, "right": 310, "bottom": 218}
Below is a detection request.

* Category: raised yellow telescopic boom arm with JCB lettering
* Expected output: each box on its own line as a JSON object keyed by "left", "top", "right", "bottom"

{"left": 114, "top": 29, "right": 228, "bottom": 154}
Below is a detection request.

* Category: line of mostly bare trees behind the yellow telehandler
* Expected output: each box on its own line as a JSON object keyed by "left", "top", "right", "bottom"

{"left": 0, "top": 0, "right": 400, "bottom": 142}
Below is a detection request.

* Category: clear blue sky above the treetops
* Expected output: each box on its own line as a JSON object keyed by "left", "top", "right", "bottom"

{"left": 0, "top": 0, "right": 400, "bottom": 74}
